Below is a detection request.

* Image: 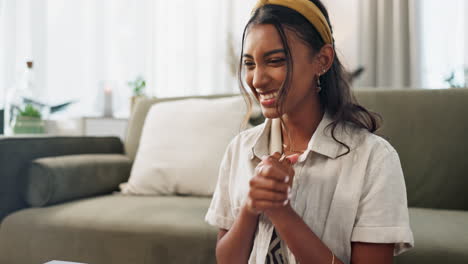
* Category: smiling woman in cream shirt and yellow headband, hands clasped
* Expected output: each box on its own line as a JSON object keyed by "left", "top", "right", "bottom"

{"left": 206, "top": 0, "right": 413, "bottom": 264}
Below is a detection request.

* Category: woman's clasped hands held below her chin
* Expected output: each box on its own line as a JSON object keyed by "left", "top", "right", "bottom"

{"left": 246, "top": 152, "right": 298, "bottom": 215}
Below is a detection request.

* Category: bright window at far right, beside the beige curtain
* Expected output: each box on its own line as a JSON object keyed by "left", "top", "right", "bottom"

{"left": 421, "top": 0, "right": 468, "bottom": 88}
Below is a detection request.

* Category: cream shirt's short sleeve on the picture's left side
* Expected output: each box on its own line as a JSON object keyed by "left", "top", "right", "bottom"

{"left": 205, "top": 141, "right": 234, "bottom": 230}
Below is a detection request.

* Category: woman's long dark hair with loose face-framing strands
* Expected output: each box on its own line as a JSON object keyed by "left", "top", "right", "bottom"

{"left": 238, "top": 0, "right": 381, "bottom": 156}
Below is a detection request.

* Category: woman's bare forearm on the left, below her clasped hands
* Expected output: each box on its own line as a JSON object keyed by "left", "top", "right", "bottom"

{"left": 216, "top": 205, "right": 258, "bottom": 264}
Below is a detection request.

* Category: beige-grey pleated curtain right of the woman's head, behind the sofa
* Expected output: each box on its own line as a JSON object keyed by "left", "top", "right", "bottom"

{"left": 357, "top": 0, "right": 424, "bottom": 88}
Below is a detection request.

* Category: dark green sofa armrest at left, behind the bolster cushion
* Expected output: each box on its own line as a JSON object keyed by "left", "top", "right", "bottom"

{"left": 0, "top": 137, "right": 123, "bottom": 222}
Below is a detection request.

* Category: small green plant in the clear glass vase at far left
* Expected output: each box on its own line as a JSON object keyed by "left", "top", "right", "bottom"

{"left": 13, "top": 104, "right": 44, "bottom": 134}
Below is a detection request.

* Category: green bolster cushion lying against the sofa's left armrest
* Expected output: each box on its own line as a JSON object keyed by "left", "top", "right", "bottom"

{"left": 25, "top": 154, "right": 132, "bottom": 206}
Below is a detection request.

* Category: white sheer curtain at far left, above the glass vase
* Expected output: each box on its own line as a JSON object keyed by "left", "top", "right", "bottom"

{"left": 0, "top": 0, "right": 150, "bottom": 115}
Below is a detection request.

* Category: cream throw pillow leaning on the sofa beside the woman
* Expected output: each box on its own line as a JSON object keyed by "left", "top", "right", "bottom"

{"left": 121, "top": 96, "right": 246, "bottom": 196}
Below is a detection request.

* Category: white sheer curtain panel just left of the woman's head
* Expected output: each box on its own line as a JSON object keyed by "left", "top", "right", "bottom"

{"left": 152, "top": 0, "right": 233, "bottom": 97}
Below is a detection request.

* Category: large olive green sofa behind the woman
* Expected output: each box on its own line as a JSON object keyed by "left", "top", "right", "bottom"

{"left": 0, "top": 89, "right": 468, "bottom": 264}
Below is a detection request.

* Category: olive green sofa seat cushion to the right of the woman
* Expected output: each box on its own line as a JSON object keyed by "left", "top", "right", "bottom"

{"left": 395, "top": 208, "right": 468, "bottom": 264}
